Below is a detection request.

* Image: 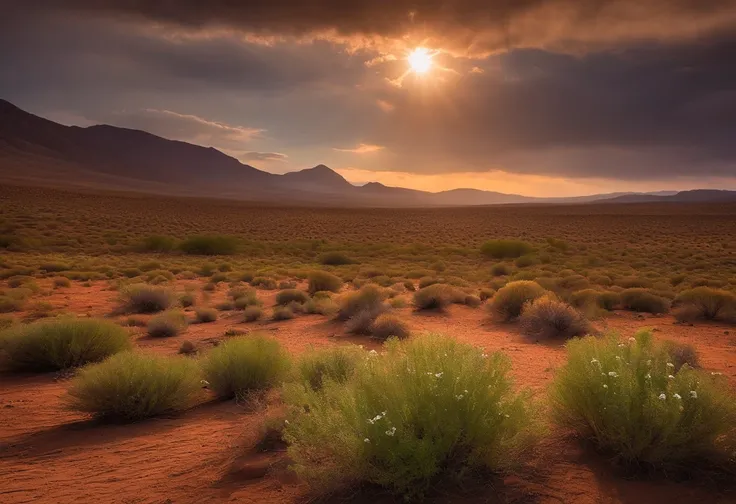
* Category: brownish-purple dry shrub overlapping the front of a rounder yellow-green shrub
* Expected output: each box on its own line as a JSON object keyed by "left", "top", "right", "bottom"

{"left": 519, "top": 295, "right": 590, "bottom": 339}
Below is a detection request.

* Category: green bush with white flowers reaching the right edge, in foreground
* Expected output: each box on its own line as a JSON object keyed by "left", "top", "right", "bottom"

{"left": 552, "top": 331, "right": 736, "bottom": 469}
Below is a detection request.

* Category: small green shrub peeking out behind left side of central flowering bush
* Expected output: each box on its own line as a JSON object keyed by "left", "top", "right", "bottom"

{"left": 294, "top": 345, "right": 366, "bottom": 390}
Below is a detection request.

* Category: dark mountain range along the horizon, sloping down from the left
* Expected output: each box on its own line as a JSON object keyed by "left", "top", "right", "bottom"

{"left": 0, "top": 100, "right": 736, "bottom": 207}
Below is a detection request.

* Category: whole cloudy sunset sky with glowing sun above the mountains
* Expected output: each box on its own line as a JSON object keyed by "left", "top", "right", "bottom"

{"left": 0, "top": 0, "right": 736, "bottom": 196}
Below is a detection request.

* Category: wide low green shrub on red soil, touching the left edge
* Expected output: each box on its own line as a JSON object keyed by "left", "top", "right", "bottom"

{"left": 0, "top": 318, "right": 130, "bottom": 371}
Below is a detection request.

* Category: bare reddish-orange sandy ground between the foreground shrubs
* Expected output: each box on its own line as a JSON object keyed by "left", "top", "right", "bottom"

{"left": 0, "top": 283, "right": 736, "bottom": 504}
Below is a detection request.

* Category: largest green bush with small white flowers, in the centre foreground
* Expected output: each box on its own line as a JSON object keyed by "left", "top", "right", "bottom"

{"left": 284, "top": 335, "right": 536, "bottom": 500}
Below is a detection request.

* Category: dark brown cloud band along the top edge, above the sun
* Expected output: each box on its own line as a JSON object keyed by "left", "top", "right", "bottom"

{"left": 15, "top": 0, "right": 736, "bottom": 53}
